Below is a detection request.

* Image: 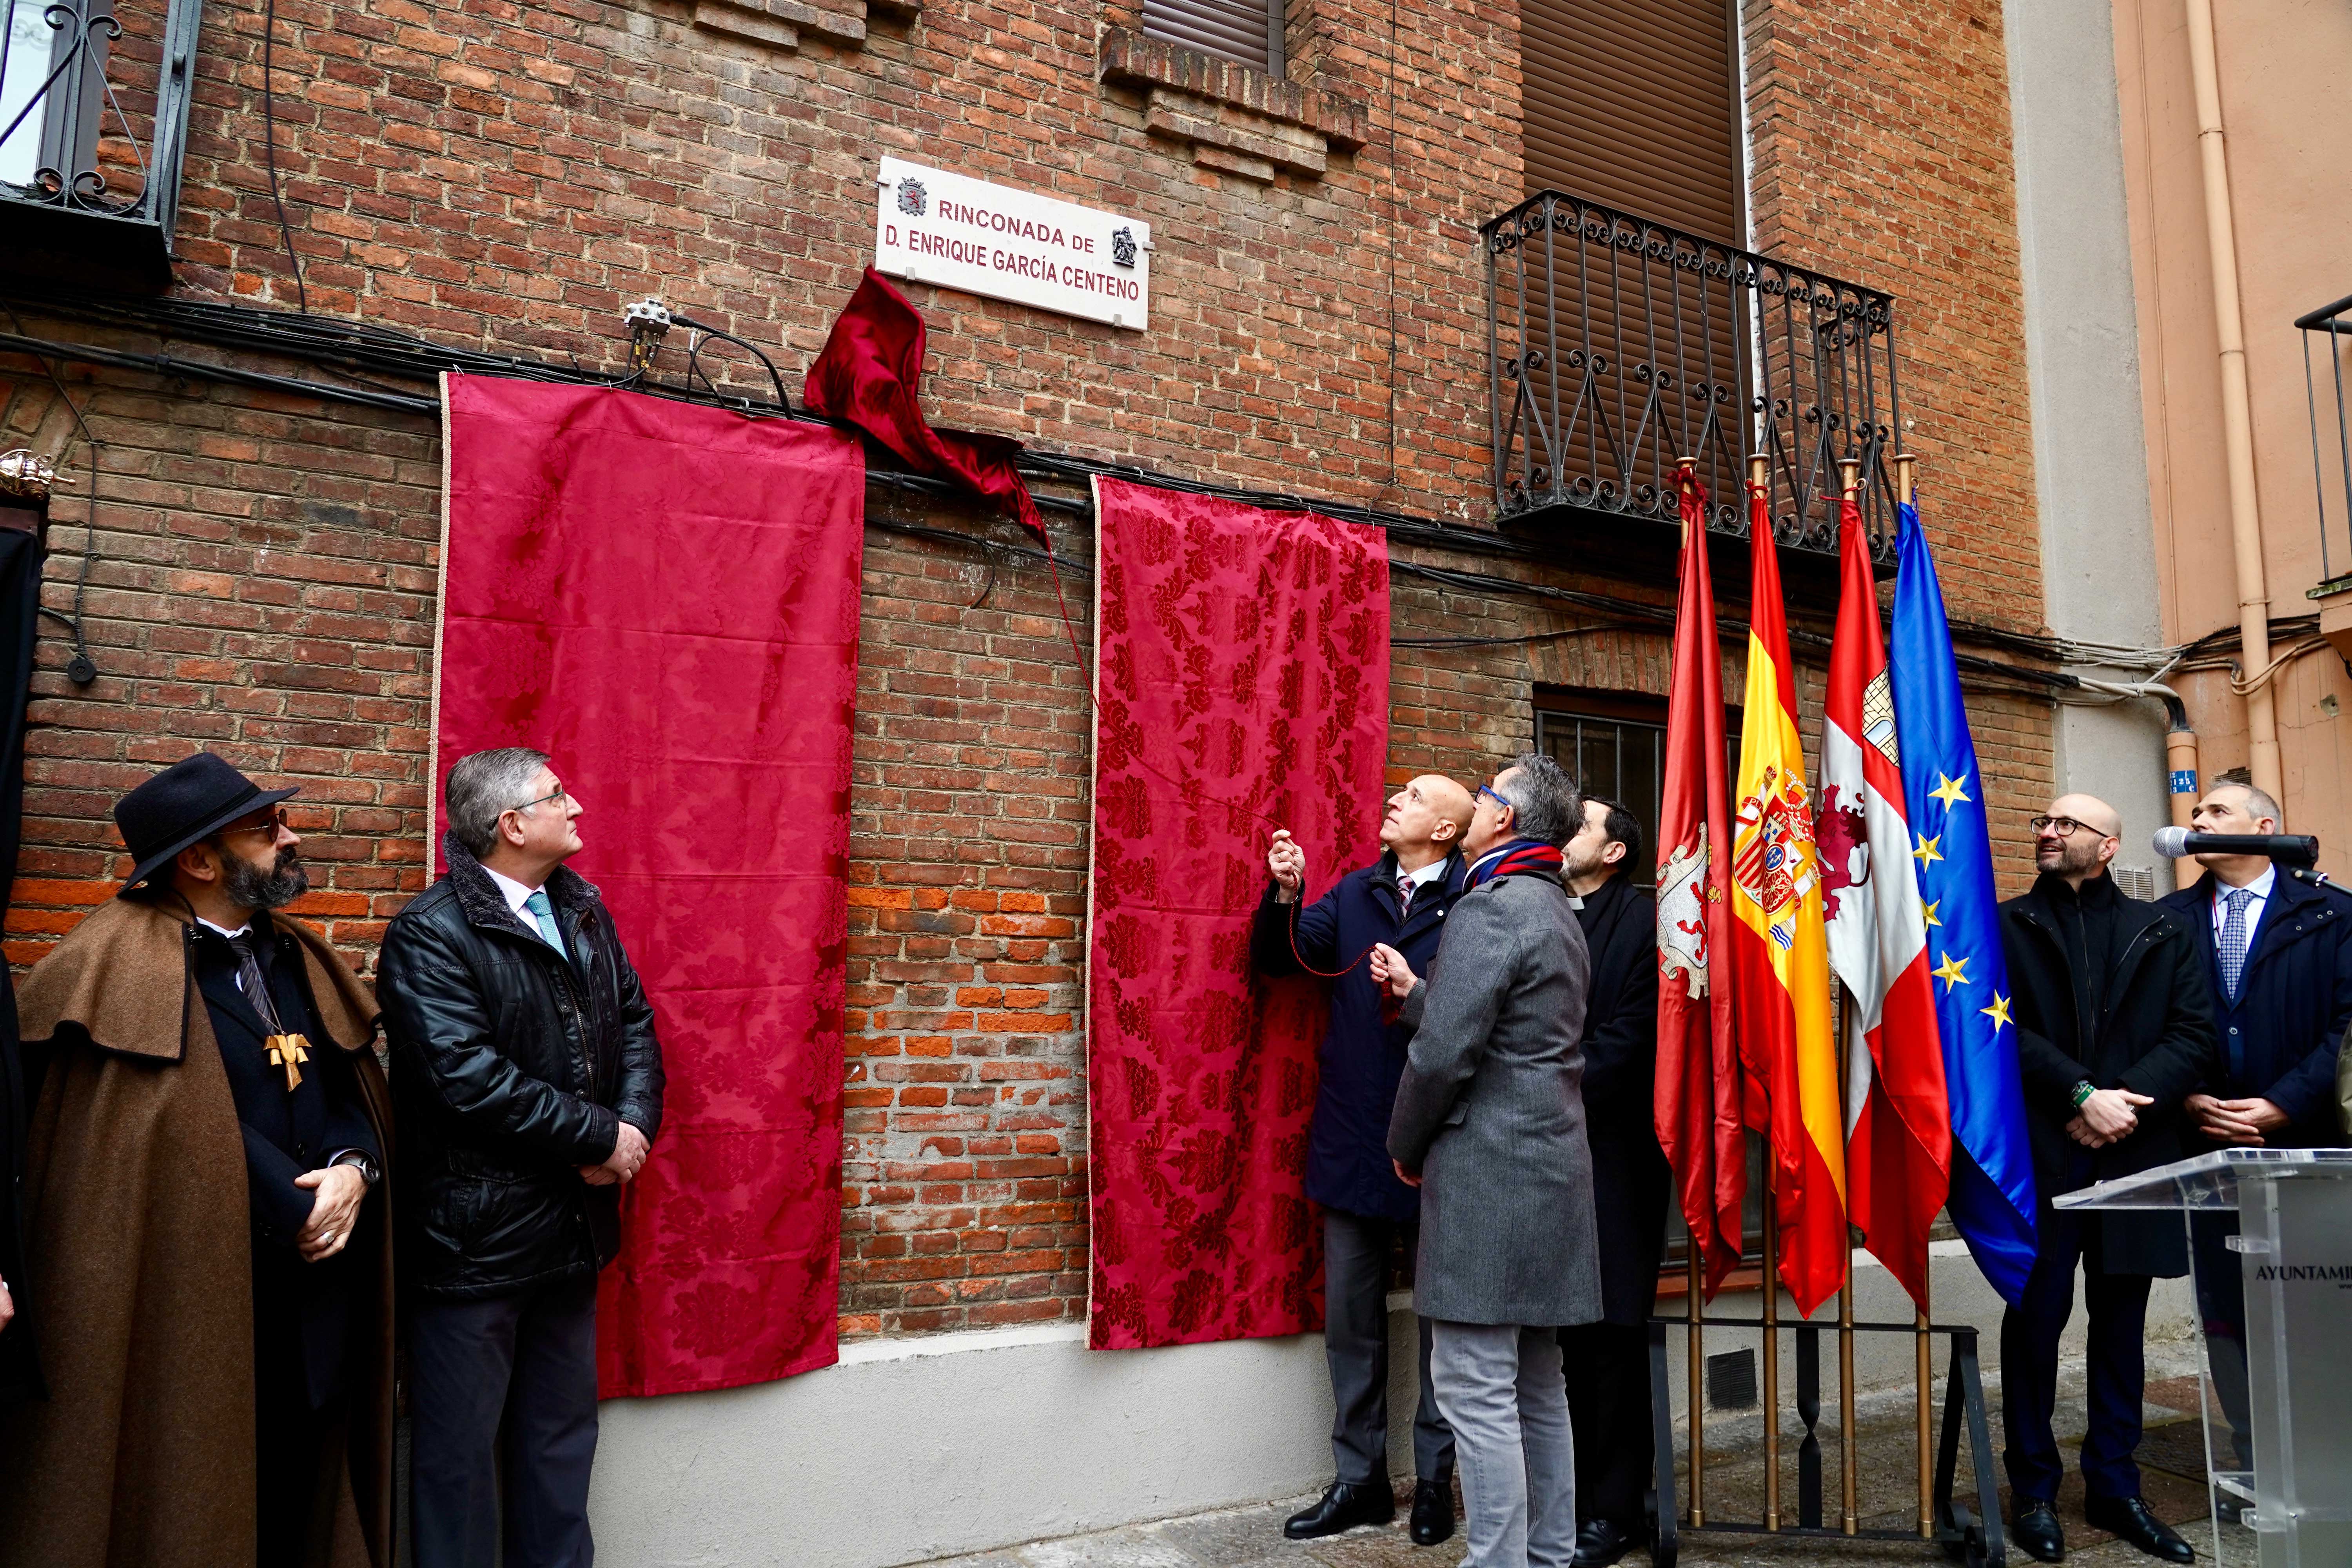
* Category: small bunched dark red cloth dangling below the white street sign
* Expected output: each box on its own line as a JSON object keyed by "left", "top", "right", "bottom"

{"left": 800, "top": 268, "right": 1044, "bottom": 534}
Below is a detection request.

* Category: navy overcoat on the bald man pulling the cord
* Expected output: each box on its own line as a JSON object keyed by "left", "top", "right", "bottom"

{"left": 1249, "top": 851, "right": 1470, "bottom": 1220}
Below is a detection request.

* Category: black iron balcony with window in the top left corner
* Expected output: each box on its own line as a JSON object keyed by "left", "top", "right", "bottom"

{"left": 0, "top": 0, "right": 202, "bottom": 292}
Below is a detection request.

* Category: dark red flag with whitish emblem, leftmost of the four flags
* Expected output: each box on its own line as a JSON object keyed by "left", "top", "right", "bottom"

{"left": 1656, "top": 463, "right": 1748, "bottom": 1295}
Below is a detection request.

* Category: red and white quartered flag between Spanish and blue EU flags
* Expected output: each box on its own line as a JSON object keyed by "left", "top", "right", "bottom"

{"left": 1813, "top": 498, "right": 1952, "bottom": 1309}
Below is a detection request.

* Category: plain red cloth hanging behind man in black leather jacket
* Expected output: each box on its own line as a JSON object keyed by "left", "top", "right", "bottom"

{"left": 433, "top": 376, "right": 866, "bottom": 1396}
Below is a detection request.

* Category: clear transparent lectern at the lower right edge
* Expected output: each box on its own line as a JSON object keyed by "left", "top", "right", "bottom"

{"left": 2056, "top": 1150, "right": 2352, "bottom": 1568}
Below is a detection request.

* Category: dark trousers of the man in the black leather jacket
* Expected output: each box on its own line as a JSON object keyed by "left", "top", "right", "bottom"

{"left": 409, "top": 1276, "right": 595, "bottom": 1568}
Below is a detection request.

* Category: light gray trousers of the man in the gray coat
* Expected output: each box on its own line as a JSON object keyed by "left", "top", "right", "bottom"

{"left": 1430, "top": 1323, "right": 1576, "bottom": 1568}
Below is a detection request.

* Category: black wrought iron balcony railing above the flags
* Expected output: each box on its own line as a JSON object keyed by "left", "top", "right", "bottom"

{"left": 1479, "top": 191, "right": 1903, "bottom": 564}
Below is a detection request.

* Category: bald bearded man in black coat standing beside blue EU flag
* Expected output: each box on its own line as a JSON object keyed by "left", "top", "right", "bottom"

{"left": 1994, "top": 795, "right": 2220, "bottom": 1563}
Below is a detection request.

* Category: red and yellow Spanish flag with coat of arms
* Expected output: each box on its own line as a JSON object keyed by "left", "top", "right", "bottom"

{"left": 1731, "top": 484, "right": 1846, "bottom": 1314}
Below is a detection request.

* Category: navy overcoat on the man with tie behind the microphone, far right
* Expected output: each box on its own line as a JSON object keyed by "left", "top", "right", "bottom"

{"left": 2157, "top": 867, "right": 2352, "bottom": 1147}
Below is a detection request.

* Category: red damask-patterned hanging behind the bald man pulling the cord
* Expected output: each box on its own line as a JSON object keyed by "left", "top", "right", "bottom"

{"left": 1087, "top": 479, "right": 1388, "bottom": 1349}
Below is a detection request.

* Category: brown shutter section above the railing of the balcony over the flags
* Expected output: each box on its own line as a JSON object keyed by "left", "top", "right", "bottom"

{"left": 1519, "top": 0, "right": 1748, "bottom": 245}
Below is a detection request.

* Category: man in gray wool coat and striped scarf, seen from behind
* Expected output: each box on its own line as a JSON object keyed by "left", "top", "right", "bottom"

{"left": 1371, "top": 752, "right": 1602, "bottom": 1568}
